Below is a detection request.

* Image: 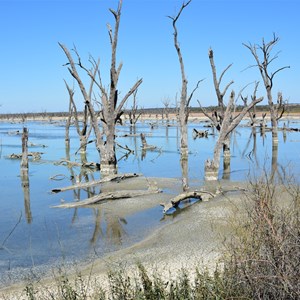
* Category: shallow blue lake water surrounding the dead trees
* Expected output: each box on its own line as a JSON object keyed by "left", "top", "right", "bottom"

{"left": 0, "top": 120, "right": 300, "bottom": 285}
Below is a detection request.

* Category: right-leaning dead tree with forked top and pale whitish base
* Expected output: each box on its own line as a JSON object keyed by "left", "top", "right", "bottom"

{"left": 205, "top": 91, "right": 263, "bottom": 180}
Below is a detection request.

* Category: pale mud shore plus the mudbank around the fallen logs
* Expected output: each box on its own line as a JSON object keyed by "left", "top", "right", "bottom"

{"left": 0, "top": 177, "right": 248, "bottom": 299}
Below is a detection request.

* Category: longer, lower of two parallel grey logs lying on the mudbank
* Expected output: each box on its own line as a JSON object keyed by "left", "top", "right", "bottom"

{"left": 52, "top": 188, "right": 161, "bottom": 208}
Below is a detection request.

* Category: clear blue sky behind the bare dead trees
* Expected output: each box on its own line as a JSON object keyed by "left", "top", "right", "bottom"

{"left": 0, "top": 0, "right": 300, "bottom": 113}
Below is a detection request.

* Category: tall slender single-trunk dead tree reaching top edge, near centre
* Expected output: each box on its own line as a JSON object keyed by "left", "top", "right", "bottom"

{"left": 169, "top": 0, "right": 200, "bottom": 159}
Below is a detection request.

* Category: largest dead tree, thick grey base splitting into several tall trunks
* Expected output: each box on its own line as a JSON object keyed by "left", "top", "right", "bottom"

{"left": 59, "top": 0, "right": 142, "bottom": 175}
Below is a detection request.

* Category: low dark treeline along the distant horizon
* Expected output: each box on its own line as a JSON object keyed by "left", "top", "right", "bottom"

{"left": 0, "top": 103, "right": 300, "bottom": 120}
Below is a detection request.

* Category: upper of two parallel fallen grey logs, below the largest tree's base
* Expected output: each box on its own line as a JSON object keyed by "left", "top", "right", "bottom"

{"left": 51, "top": 173, "right": 139, "bottom": 193}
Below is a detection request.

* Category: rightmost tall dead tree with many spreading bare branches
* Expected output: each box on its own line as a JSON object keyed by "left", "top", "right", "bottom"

{"left": 243, "top": 34, "right": 290, "bottom": 143}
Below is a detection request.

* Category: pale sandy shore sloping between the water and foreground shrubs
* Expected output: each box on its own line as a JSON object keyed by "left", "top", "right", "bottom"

{"left": 0, "top": 177, "right": 247, "bottom": 299}
